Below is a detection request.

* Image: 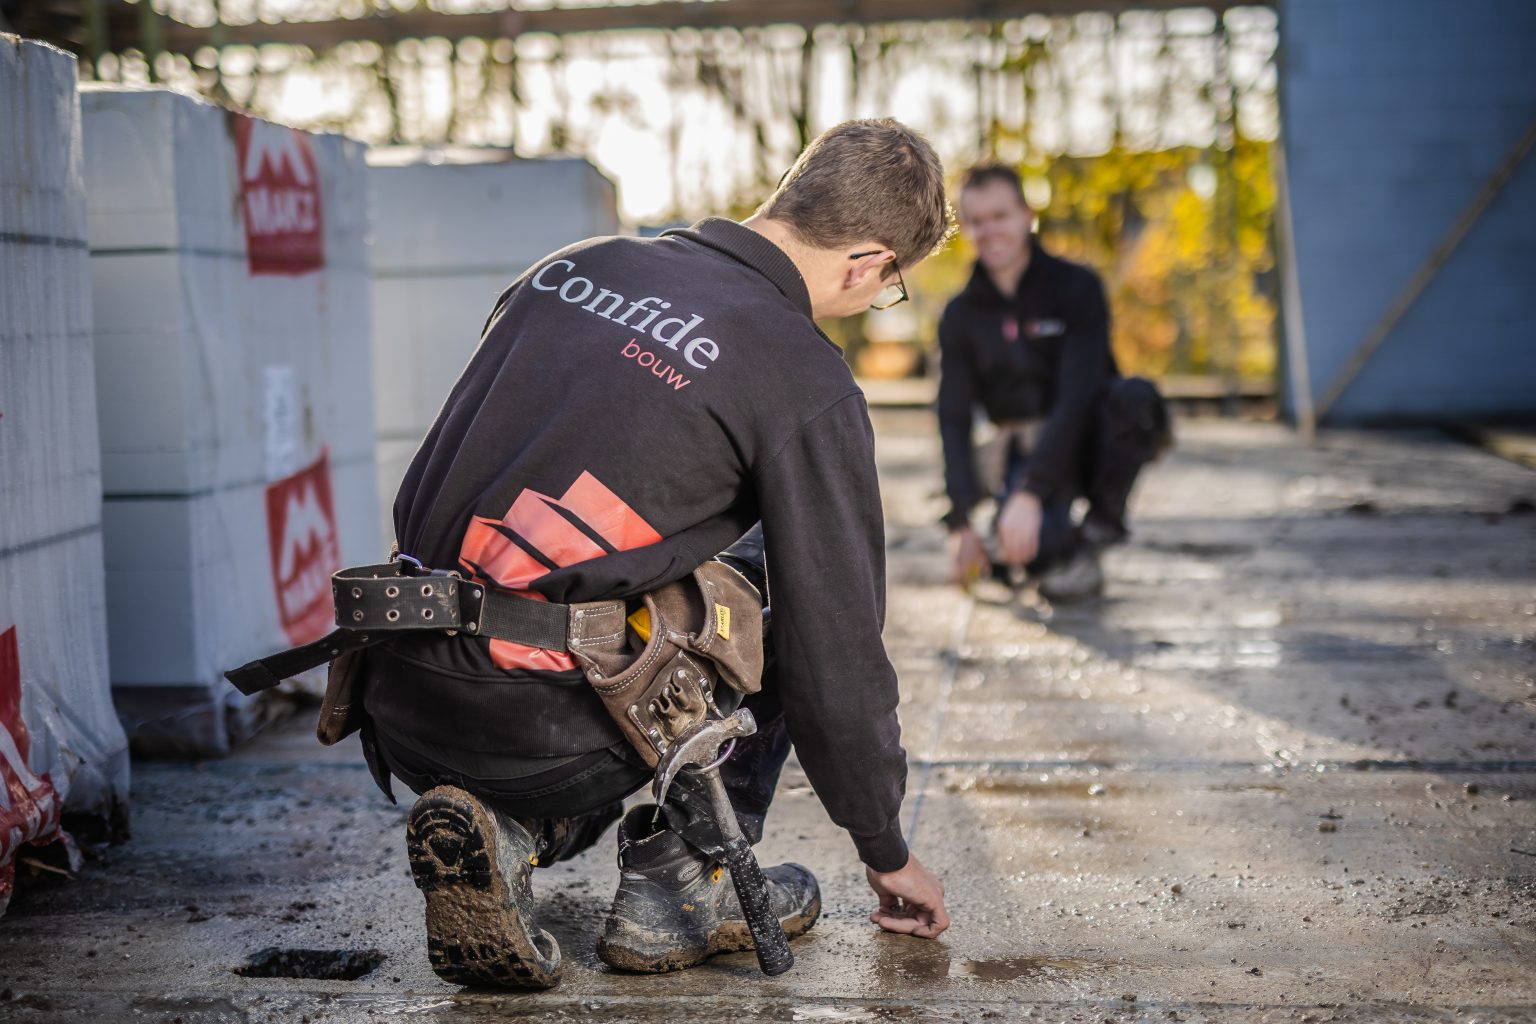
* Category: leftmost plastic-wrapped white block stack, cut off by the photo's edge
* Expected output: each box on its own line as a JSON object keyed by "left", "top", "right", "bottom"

{"left": 0, "top": 35, "right": 129, "bottom": 865}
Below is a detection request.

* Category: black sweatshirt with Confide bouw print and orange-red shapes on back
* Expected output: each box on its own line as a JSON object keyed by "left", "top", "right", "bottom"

{"left": 369, "top": 218, "right": 906, "bottom": 870}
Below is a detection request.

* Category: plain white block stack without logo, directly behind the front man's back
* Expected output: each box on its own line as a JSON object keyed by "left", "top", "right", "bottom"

{"left": 369, "top": 152, "right": 619, "bottom": 539}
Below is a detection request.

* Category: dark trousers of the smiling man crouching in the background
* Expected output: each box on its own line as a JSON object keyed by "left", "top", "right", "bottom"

{"left": 998, "top": 378, "right": 1172, "bottom": 573}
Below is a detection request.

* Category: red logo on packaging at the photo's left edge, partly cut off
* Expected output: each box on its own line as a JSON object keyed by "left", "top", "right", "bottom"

{"left": 0, "top": 626, "right": 61, "bottom": 909}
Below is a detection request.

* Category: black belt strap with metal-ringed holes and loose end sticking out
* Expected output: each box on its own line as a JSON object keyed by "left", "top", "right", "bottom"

{"left": 224, "top": 556, "right": 586, "bottom": 694}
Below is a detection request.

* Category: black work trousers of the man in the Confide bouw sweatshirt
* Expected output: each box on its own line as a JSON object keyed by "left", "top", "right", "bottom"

{"left": 364, "top": 527, "right": 790, "bottom": 866}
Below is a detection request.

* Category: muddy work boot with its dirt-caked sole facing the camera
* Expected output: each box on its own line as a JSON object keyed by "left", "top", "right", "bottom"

{"left": 406, "top": 786, "right": 561, "bottom": 989}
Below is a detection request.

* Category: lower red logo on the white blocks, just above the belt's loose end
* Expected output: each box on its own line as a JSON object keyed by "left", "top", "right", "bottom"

{"left": 267, "top": 453, "right": 341, "bottom": 645}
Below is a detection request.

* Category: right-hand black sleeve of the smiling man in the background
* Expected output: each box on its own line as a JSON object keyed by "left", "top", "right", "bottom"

{"left": 1023, "top": 272, "right": 1111, "bottom": 500}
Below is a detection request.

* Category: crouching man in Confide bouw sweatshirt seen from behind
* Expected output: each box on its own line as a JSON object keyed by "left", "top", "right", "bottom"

{"left": 242, "top": 120, "right": 949, "bottom": 989}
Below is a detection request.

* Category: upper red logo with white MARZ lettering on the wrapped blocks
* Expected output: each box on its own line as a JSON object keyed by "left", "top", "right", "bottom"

{"left": 230, "top": 114, "right": 326, "bottom": 275}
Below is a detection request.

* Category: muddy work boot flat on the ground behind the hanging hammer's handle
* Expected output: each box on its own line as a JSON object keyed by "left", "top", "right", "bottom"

{"left": 598, "top": 804, "right": 822, "bottom": 973}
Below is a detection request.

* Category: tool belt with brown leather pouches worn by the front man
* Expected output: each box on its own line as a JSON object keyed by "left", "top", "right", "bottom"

{"left": 224, "top": 556, "right": 763, "bottom": 766}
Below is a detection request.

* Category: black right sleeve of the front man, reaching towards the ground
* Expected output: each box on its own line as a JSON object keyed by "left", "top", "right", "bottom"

{"left": 756, "top": 393, "right": 906, "bottom": 872}
